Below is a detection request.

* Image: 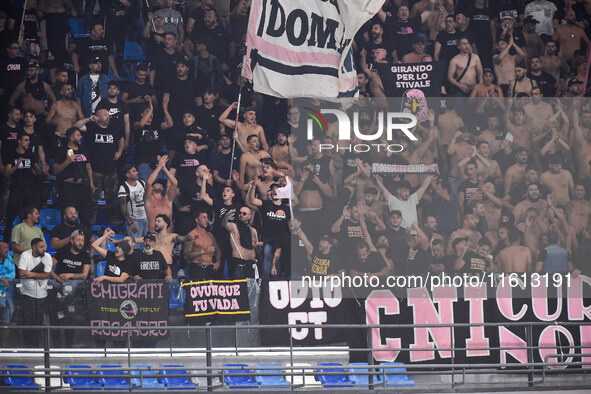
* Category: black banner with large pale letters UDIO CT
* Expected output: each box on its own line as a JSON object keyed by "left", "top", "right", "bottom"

{"left": 259, "top": 281, "right": 365, "bottom": 346}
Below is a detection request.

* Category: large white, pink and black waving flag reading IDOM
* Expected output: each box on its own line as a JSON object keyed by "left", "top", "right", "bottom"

{"left": 244, "top": 0, "right": 385, "bottom": 98}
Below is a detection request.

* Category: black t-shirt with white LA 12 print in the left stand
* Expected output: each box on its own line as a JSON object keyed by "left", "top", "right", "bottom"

{"left": 85, "top": 123, "right": 123, "bottom": 174}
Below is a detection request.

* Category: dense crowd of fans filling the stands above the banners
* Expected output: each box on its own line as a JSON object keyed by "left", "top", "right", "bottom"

{"left": 0, "top": 0, "right": 591, "bottom": 340}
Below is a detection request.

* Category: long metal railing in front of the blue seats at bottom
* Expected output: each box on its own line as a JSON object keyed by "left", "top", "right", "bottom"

{"left": 0, "top": 322, "right": 591, "bottom": 391}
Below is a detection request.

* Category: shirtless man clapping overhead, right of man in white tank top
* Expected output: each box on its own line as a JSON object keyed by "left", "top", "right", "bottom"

{"left": 144, "top": 155, "right": 178, "bottom": 234}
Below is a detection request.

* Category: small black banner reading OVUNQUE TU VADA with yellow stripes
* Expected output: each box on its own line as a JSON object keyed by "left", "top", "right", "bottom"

{"left": 183, "top": 279, "right": 250, "bottom": 325}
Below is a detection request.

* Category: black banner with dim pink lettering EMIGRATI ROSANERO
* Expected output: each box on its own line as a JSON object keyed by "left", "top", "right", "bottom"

{"left": 86, "top": 281, "right": 170, "bottom": 340}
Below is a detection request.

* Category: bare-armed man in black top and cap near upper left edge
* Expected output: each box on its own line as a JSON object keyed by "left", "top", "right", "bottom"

{"left": 8, "top": 60, "right": 55, "bottom": 116}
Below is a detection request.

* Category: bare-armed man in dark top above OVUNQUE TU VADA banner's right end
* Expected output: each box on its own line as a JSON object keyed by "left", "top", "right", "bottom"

{"left": 222, "top": 206, "right": 263, "bottom": 279}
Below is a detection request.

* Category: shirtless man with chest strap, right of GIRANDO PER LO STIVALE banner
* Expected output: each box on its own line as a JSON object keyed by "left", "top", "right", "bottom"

{"left": 447, "top": 37, "right": 483, "bottom": 96}
